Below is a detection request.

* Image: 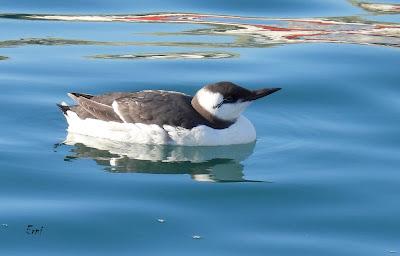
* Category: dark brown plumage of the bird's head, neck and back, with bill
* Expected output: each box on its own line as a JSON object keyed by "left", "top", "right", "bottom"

{"left": 59, "top": 82, "right": 280, "bottom": 129}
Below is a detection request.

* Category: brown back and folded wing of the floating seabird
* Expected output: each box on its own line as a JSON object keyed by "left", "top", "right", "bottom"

{"left": 70, "top": 90, "right": 210, "bottom": 129}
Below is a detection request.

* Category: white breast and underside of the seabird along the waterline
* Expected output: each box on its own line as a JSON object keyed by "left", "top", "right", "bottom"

{"left": 65, "top": 111, "right": 256, "bottom": 146}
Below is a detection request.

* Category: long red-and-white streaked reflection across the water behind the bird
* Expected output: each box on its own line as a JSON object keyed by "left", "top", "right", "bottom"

{"left": 0, "top": 11, "right": 400, "bottom": 51}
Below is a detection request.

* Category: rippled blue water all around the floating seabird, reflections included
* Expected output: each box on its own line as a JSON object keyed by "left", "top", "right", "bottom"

{"left": 0, "top": 0, "right": 400, "bottom": 256}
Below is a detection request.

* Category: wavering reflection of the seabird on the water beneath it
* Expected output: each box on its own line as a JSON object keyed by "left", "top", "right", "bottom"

{"left": 62, "top": 133, "right": 255, "bottom": 182}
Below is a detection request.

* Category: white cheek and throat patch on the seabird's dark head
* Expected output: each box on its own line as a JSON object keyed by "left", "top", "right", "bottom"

{"left": 196, "top": 88, "right": 251, "bottom": 121}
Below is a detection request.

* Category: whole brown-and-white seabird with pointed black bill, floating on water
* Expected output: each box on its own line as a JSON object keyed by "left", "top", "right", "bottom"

{"left": 57, "top": 82, "right": 281, "bottom": 146}
